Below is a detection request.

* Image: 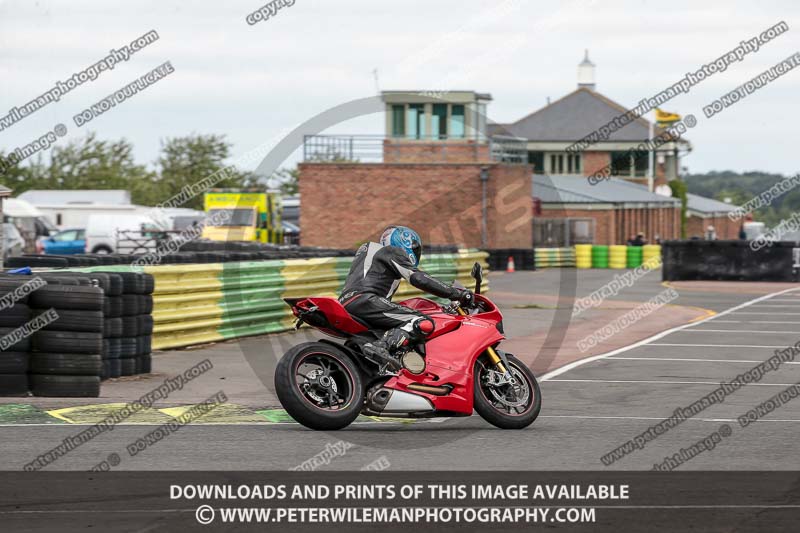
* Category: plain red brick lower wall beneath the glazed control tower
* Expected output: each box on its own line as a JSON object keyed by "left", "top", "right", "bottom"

{"left": 300, "top": 162, "right": 532, "bottom": 248}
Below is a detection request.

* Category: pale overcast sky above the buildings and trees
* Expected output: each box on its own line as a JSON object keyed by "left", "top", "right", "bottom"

{"left": 0, "top": 0, "right": 800, "bottom": 178}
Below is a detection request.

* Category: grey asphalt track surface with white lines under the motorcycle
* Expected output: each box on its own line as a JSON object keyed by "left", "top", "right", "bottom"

{"left": 0, "top": 271, "right": 800, "bottom": 470}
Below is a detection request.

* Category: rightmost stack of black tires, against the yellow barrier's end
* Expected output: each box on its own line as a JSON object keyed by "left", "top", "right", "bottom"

{"left": 108, "top": 272, "right": 155, "bottom": 377}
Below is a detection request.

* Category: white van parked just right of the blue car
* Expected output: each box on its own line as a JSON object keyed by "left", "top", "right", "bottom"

{"left": 86, "top": 214, "right": 163, "bottom": 254}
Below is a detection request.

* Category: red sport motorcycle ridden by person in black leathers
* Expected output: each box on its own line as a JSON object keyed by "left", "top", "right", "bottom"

{"left": 275, "top": 263, "right": 542, "bottom": 430}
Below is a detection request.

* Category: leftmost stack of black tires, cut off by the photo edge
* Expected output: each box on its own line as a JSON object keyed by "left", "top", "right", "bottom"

{"left": 0, "top": 276, "right": 36, "bottom": 396}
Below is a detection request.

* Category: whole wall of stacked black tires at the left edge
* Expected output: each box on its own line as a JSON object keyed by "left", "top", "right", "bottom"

{"left": 0, "top": 270, "right": 153, "bottom": 397}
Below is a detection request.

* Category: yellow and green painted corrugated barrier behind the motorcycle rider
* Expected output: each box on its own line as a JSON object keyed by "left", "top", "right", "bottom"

{"left": 70, "top": 250, "right": 488, "bottom": 350}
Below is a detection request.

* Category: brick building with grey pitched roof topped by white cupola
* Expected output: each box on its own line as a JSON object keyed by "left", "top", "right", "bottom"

{"left": 489, "top": 48, "right": 738, "bottom": 246}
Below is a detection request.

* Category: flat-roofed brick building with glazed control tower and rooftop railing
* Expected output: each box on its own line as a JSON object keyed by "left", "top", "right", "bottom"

{"left": 298, "top": 91, "right": 533, "bottom": 248}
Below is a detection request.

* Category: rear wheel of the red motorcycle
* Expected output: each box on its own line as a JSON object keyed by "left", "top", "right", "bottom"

{"left": 275, "top": 342, "right": 364, "bottom": 431}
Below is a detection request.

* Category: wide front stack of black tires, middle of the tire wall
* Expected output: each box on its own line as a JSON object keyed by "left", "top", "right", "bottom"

{"left": 28, "top": 272, "right": 104, "bottom": 398}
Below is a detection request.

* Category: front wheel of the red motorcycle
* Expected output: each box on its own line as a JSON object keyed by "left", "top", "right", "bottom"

{"left": 473, "top": 354, "right": 542, "bottom": 429}
